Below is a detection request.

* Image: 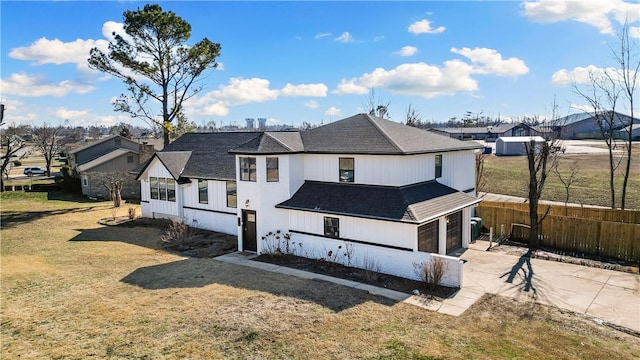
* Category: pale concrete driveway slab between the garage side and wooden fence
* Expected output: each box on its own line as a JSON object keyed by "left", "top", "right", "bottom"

{"left": 456, "top": 241, "right": 640, "bottom": 333}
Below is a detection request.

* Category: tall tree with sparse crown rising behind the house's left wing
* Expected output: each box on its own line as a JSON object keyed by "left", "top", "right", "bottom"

{"left": 89, "top": 4, "right": 220, "bottom": 145}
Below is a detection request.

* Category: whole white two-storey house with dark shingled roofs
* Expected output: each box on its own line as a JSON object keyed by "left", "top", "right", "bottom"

{"left": 138, "top": 114, "right": 482, "bottom": 286}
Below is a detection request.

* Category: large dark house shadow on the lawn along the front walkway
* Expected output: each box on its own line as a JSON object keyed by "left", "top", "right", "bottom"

{"left": 121, "top": 258, "right": 396, "bottom": 312}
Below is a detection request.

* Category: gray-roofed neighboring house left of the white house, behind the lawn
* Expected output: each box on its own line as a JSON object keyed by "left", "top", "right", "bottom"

{"left": 69, "top": 135, "right": 154, "bottom": 199}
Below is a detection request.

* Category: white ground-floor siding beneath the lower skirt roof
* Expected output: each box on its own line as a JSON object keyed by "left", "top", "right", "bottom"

{"left": 282, "top": 211, "right": 463, "bottom": 287}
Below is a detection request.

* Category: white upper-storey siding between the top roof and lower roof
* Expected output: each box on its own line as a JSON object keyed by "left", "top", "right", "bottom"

{"left": 304, "top": 150, "right": 475, "bottom": 191}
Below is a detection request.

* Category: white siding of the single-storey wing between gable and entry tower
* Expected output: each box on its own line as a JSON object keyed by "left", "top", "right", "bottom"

{"left": 182, "top": 179, "right": 238, "bottom": 235}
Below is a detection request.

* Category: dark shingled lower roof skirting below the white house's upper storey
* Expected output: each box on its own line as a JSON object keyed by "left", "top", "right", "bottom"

{"left": 276, "top": 181, "right": 480, "bottom": 224}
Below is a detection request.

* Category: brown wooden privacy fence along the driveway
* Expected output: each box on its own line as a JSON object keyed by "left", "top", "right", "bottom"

{"left": 476, "top": 201, "right": 640, "bottom": 262}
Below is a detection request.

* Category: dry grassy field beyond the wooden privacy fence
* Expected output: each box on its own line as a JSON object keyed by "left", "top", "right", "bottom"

{"left": 483, "top": 145, "right": 640, "bottom": 209}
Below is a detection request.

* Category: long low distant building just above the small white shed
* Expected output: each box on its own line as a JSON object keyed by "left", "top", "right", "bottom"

{"left": 429, "top": 123, "right": 542, "bottom": 142}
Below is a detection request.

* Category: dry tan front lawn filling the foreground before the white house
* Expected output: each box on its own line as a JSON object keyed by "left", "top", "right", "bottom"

{"left": 0, "top": 194, "right": 640, "bottom": 359}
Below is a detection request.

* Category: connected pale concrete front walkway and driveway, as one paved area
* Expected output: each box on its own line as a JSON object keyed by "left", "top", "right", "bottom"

{"left": 215, "top": 249, "right": 640, "bottom": 333}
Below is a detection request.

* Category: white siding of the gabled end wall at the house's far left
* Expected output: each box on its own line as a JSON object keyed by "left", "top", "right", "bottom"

{"left": 140, "top": 158, "right": 182, "bottom": 220}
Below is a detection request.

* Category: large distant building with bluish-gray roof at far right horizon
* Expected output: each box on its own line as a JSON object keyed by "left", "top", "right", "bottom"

{"left": 556, "top": 111, "right": 640, "bottom": 140}
